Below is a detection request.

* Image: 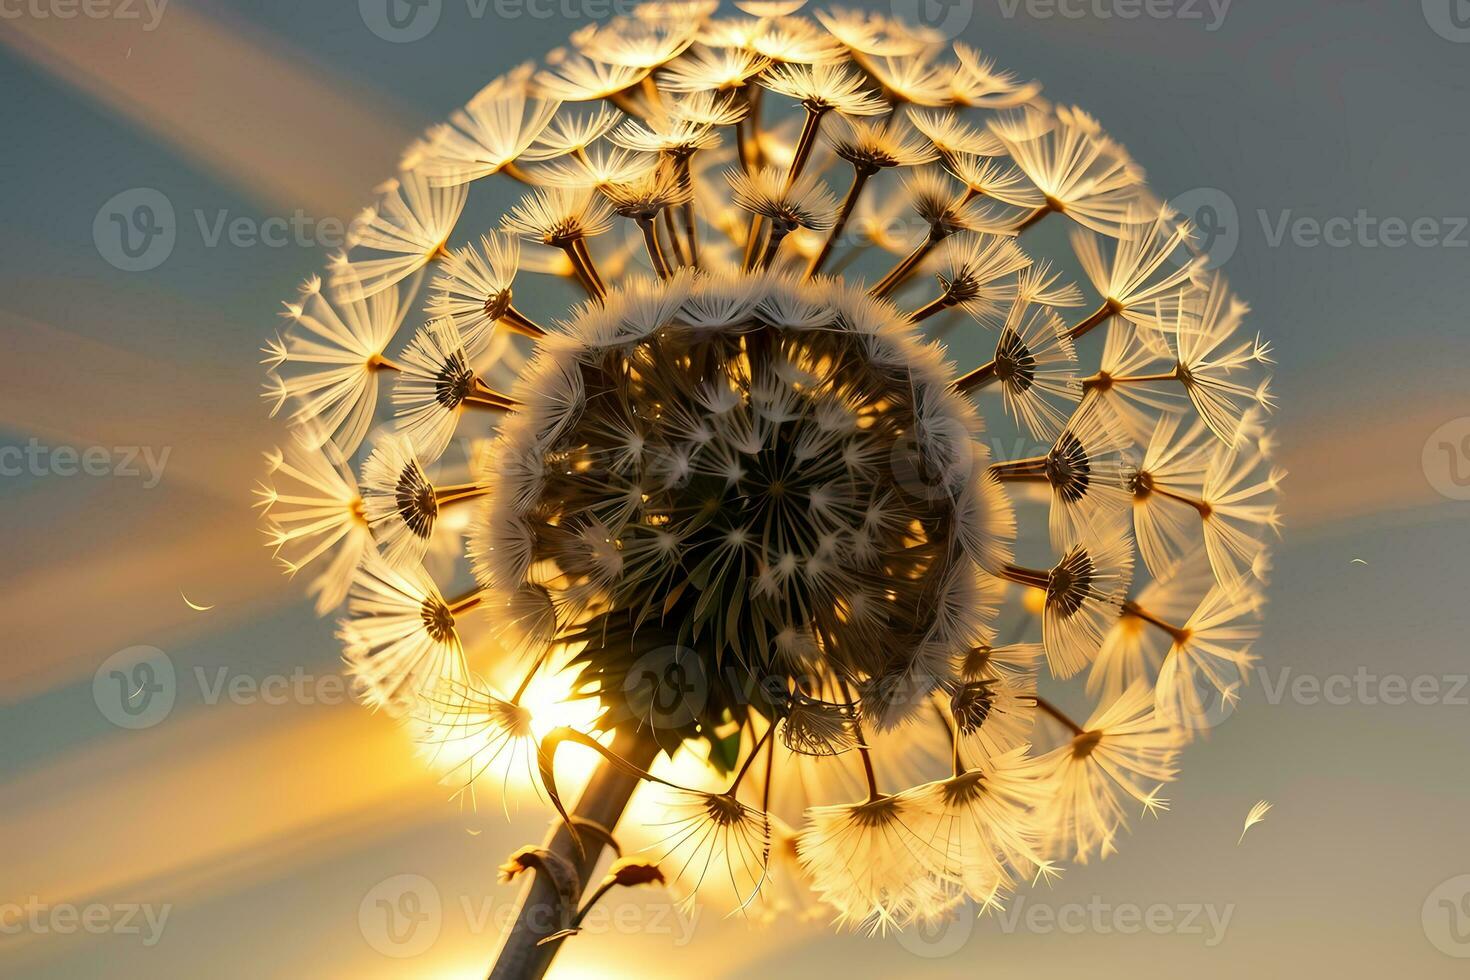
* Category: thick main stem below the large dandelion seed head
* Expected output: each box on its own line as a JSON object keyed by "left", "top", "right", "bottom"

{"left": 490, "top": 735, "right": 659, "bottom": 980}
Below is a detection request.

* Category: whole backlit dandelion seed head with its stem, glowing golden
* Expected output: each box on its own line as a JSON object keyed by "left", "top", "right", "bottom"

{"left": 257, "top": 0, "right": 1282, "bottom": 977}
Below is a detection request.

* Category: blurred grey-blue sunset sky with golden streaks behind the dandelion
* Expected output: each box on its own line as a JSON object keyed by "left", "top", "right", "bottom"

{"left": 0, "top": 0, "right": 1470, "bottom": 980}
